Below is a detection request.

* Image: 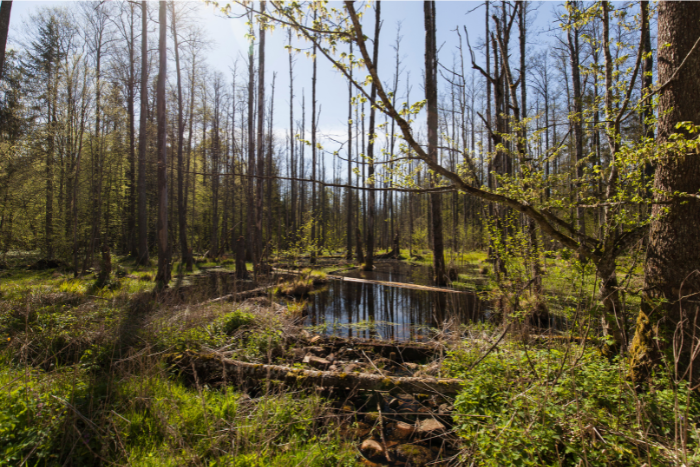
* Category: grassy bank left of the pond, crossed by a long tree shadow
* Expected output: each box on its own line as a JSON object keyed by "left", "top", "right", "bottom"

{"left": 0, "top": 262, "right": 356, "bottom": 466}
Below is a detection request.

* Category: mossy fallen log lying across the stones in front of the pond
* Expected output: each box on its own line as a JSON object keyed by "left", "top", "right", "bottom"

{"left": 221, "top": 358, "right": 463, "bottom": 395}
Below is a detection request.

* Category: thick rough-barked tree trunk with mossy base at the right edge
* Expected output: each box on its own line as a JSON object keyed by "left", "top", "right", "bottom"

{"left": 631, "top": 2, "right": 700, "bottom": 380}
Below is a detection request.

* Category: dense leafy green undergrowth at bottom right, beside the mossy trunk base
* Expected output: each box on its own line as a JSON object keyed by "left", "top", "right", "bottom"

{"left": 446, "top": 345, "right": 700, "bottom": 466}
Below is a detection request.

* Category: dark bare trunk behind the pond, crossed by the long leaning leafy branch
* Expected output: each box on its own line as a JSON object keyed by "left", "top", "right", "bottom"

{"left": 423, "top": 1, "right": 447, "bottom": 285}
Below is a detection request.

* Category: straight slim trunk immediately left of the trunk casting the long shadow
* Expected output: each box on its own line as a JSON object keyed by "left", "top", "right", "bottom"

{"left": 138, "top": 1, "right": 148, "bottom": 265}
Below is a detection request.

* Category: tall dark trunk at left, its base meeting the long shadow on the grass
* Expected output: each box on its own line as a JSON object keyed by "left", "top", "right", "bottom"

{"left": 156, "top": 2, "right": 170, "bottom": 288}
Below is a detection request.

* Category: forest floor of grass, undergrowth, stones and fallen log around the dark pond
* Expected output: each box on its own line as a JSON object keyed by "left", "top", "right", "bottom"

{"left": 0, "top": 252, "right": 700, "bottom": 467}
